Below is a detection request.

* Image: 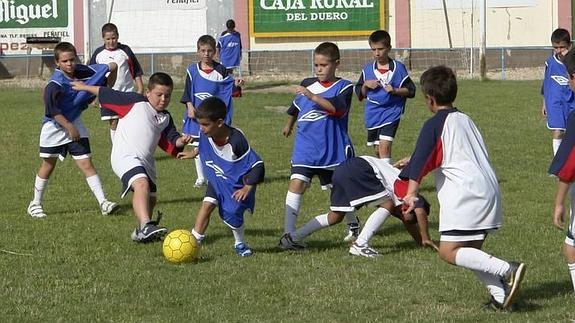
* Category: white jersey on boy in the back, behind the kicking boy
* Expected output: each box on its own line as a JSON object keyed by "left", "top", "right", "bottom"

{"left": 90, "top": 43, "right": 143, "bottom": 92}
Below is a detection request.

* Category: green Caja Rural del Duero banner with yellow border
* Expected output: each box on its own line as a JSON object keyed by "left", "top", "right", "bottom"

{"left": 249, "top": 0, "right": 385, "bottom": 37}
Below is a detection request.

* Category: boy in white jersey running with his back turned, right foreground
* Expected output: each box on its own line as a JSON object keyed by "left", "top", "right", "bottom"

{"left": 399, "top": 66, "right": 525, "bottom": 310}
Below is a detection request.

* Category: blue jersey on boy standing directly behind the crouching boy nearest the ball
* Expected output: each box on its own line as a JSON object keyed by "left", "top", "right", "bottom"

{"left": 180, "top": 62, "right": 234, "bottom": 138}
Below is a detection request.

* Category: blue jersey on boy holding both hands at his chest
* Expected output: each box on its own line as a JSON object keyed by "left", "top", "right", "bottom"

{"left": 356, "top": 59, "right": 411, "bottom": 130}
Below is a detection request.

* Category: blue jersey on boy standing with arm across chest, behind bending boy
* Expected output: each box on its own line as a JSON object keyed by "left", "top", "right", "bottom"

{"left": 288, "top": 78, "right": 353, "bottom": 168}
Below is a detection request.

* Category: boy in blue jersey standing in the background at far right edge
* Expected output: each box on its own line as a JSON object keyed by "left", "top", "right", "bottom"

{"left": 541, "top": 28, "right": 574, "bottom": 155}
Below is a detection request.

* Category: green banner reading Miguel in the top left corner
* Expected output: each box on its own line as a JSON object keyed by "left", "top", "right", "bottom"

{"left": 0, "top": 0, "right": 68, "bottom": 29}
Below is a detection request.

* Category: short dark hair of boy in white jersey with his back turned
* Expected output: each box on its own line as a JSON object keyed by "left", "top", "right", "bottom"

{"left": 419, "top": 65, "right": 457, "bottom": 104}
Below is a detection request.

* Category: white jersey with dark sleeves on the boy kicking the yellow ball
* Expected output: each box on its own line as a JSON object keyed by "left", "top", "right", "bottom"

{"left": 98, "top": 87, "right": 180, "bottom": 183}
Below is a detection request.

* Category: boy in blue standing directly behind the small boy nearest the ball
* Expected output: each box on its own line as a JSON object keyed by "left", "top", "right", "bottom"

{"left": 180, "top": 35, "right": 243, "bottom": 187}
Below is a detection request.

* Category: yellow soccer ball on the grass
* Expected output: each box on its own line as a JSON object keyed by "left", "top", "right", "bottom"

{"left": 162, "top": 229, "right": 199, "bottom": 264}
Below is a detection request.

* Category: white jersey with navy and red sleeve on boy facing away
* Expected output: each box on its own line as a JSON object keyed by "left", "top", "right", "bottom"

{"left": 399, "top": 108, "right": 503, "bottom": 231}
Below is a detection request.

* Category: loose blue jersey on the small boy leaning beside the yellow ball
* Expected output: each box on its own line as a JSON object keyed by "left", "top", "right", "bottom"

{"left": 198, "top": 127, "right": 263, "bottom": 228}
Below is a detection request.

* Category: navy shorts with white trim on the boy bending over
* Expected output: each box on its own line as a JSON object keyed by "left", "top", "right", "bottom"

{"left": 330, "top": 157, "right": 390, "bottom": 212}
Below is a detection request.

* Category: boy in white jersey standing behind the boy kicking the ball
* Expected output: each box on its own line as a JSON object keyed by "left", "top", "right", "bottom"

{"left": 90, "top": 23, "right": 144, "bottom": 144}
